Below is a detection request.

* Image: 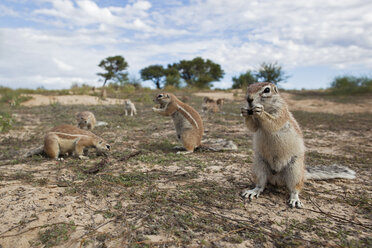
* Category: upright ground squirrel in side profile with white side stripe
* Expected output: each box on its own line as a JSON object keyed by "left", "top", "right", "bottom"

{"left": 152, "top": 93, "right": 204, "bottom": 153}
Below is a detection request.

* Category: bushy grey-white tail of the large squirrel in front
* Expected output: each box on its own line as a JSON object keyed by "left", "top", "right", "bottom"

{"left": 305, "top": 164, "right": 355, "bottom": 180}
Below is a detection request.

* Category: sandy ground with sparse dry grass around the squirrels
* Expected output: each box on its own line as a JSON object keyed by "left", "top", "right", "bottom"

{"left": 0, "top": 92, "right": 372, "bottom": 247}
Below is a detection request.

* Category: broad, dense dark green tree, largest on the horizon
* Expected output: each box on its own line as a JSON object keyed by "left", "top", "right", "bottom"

{"left": 168, "top": 57, "right": 224, "bottom": 88}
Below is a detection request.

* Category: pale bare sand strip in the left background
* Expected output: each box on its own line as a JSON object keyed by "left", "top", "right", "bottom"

{"left": 21, "top": 94, "right": 124, "bottom": 107}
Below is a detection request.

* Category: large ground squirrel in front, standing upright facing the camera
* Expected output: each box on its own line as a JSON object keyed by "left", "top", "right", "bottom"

{"left": 241, "top": 83, "right": 355, "bottom": 208}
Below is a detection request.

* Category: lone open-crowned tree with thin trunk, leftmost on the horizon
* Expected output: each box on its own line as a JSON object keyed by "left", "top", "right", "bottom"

{"left": 97, "top": 55, "right": 128, "bottom": 87}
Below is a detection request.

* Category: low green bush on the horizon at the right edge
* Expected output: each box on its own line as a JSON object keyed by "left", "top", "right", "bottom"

{"left": 331, "top": 76, "right": 372, "bottom": 94}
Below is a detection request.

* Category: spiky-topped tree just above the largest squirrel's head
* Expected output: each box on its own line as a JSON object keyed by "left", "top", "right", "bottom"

{"left": 256, "top": 62, "right": 288, "bottom": 84}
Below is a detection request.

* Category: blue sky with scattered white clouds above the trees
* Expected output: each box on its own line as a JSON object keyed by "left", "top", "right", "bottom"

{"left": 0, "top": 0, "right": 372, "bottom": 89}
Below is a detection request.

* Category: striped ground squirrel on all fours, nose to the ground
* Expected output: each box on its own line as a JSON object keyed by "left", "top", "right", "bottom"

{"left": 25, "top": 125, "right": 111, "bottom": 160}
